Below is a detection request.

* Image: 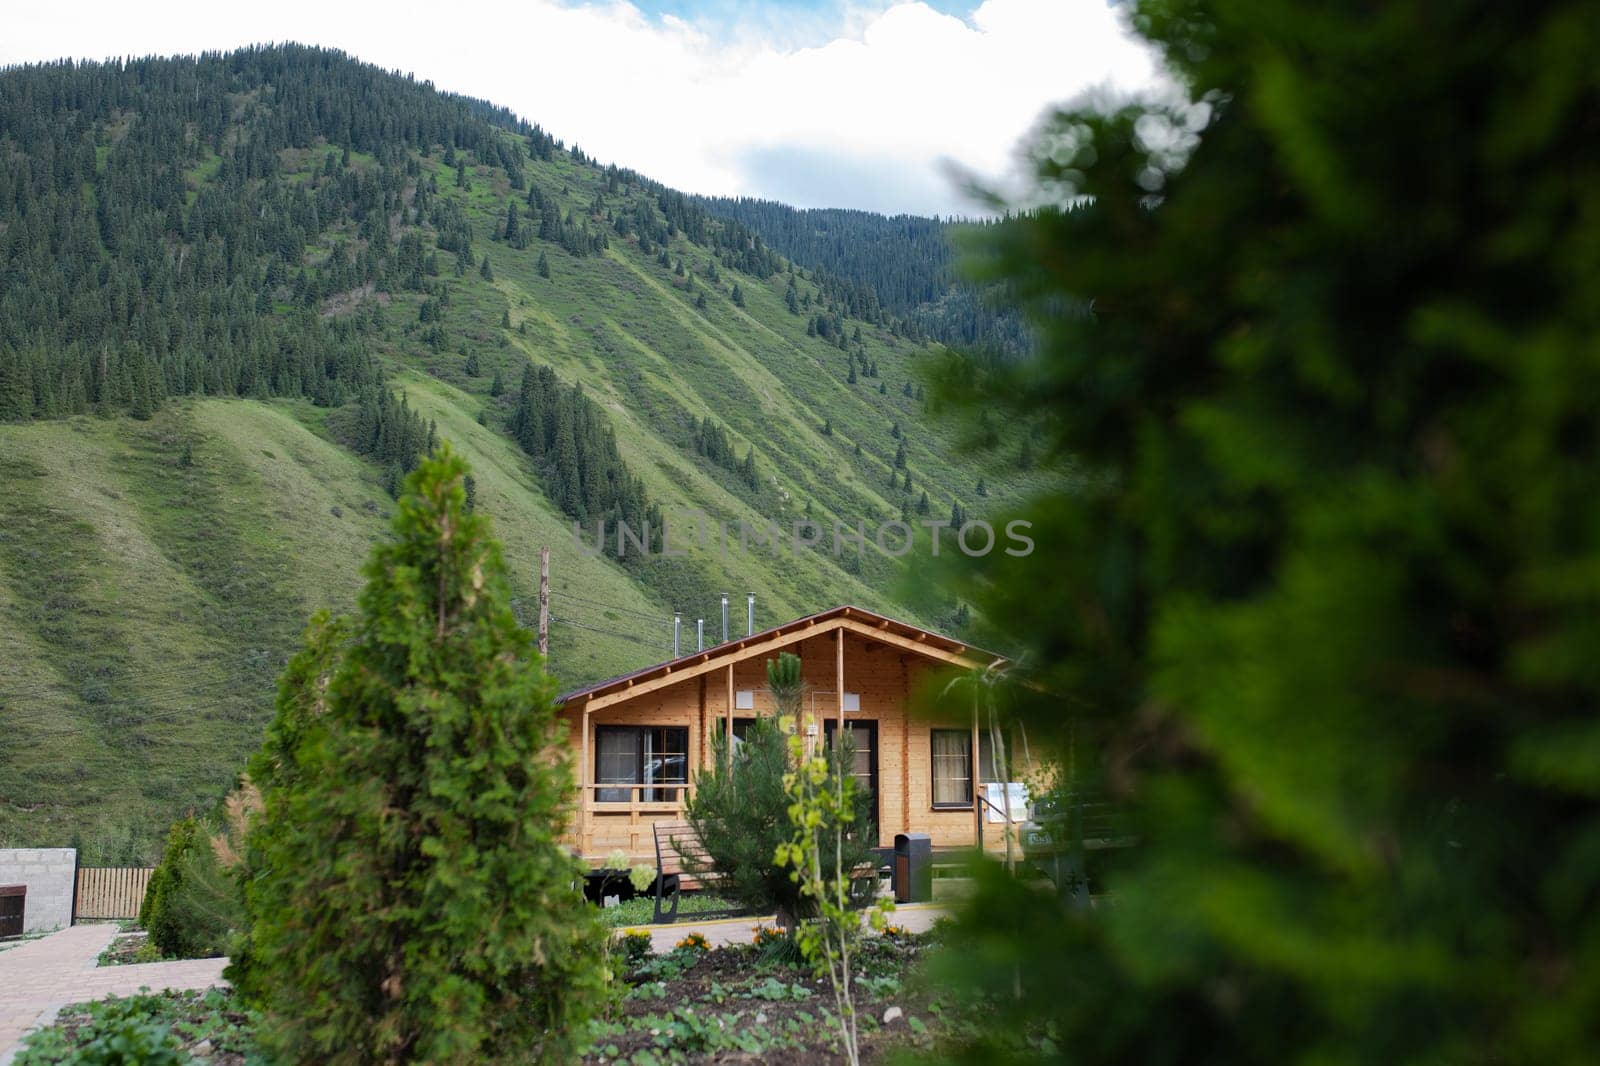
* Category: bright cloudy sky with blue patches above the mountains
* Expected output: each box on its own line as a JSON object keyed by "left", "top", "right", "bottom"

{"left": 0, "top": 0, "right": 1160, "bottom": 214}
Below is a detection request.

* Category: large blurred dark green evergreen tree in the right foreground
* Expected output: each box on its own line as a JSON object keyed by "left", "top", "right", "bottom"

{"left": 946, "top": 0, "right": 1600, "bottom": 1063}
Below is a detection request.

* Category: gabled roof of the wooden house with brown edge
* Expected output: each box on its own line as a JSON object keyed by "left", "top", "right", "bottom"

{"left": 557, "top": 605, "right": 1005, "bottom": 709}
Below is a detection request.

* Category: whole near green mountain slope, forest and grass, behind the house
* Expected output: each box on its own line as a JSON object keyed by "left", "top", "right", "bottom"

{"left": 0, "top": 46, "right": 1032, "bottom": 861}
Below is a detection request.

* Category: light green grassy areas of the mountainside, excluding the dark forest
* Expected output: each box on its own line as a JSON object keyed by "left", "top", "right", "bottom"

{"left": 0, "top": 49, "right": 1049, "bottom": 861}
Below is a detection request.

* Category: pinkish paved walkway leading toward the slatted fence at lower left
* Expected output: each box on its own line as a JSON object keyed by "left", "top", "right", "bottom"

{"left": 0, "top": 922, "right": 227, "bottom": 1066}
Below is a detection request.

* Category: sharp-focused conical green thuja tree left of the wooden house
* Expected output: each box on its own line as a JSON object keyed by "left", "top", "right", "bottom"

{"left": 242, "top": 447, "right": 605, "bottom": 1063}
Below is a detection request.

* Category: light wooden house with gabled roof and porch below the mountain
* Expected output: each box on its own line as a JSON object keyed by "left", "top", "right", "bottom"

{"left": 562, "top": 607, "right": 1014, "bottom": 866}
